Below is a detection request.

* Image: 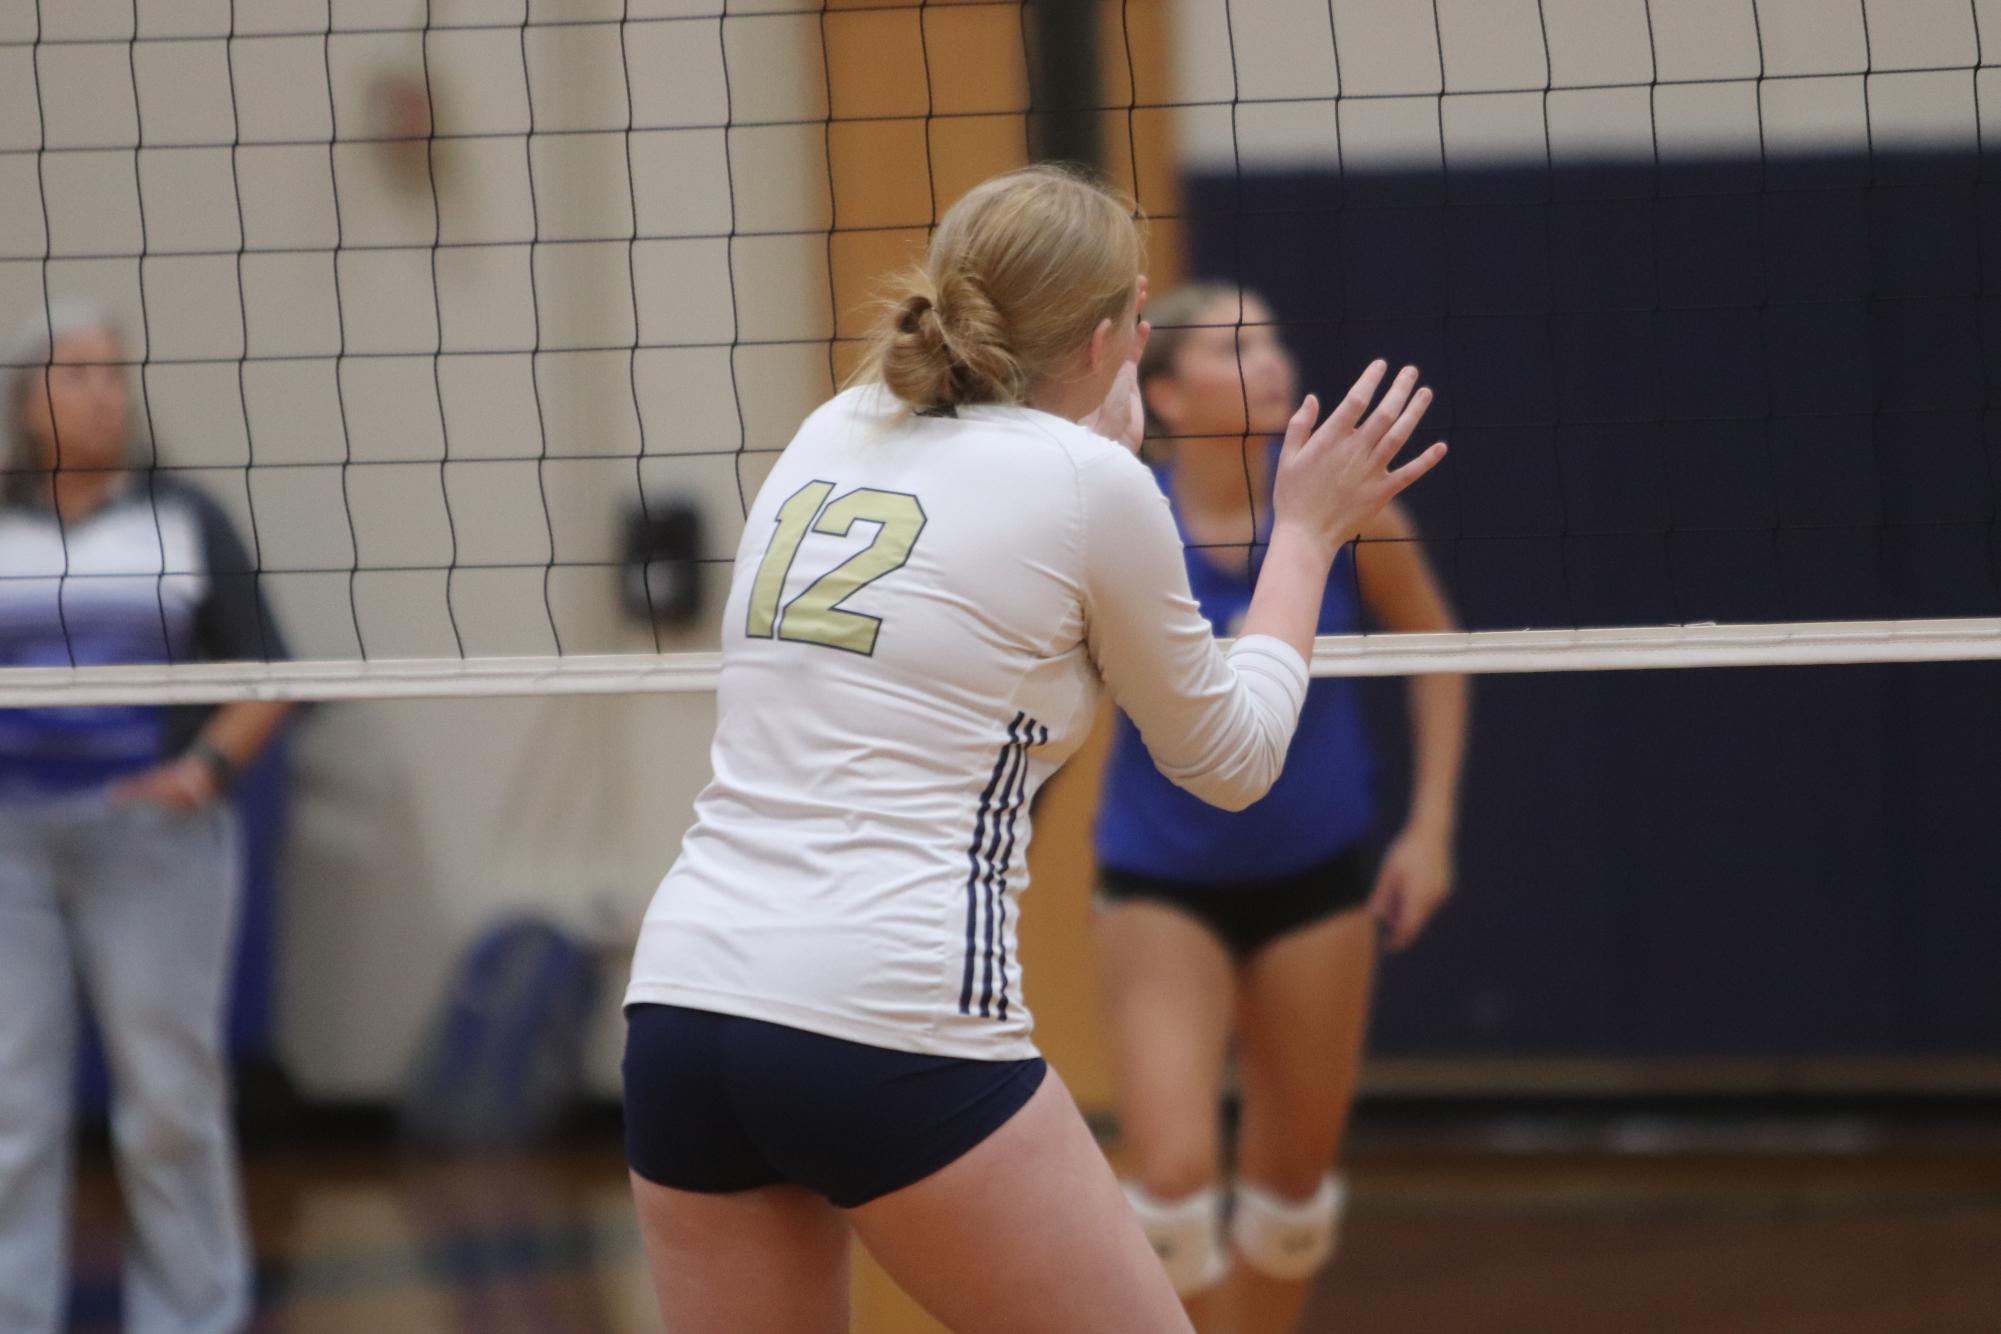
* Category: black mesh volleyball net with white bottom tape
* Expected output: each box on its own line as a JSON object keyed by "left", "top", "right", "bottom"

{"left": 0, "top": 0, "right": 2001, "bottom": 704}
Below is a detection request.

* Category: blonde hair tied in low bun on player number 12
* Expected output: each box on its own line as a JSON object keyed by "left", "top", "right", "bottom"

{"left": 854, "top": 166, "right": 1145, "bottom": 408}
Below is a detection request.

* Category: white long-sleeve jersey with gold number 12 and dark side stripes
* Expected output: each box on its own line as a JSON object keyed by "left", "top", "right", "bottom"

{"left": 626, "top": 388, "right": 1307, "bottom": 1060}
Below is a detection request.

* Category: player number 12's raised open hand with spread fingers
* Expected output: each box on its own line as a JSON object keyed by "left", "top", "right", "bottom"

{"left": 1273, "top": 360, "right": 1445, "bottom": 548}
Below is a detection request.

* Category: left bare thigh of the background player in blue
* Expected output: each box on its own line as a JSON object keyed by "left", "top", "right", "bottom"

{"left": 1093, "top": 900, "right": 1237, "bottom": 1198}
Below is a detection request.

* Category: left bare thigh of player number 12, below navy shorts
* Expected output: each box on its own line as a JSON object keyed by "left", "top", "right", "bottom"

{"left": 632, "top": 1174, "right": 848, "bottom": 1334}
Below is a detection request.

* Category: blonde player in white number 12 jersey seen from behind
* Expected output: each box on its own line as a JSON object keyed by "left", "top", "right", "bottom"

{"left": 624, "top": 168, "right": 1445, "bottom": 1334}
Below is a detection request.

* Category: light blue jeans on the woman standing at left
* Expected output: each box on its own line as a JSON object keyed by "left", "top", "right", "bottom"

{"left": 0, "top": 792, "right": 250, "bottom": 1334}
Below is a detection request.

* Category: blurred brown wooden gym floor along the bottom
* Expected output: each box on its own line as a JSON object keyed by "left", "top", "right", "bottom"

{"left": 72, "top": 1122, "right": 2001, "bottom": 1334}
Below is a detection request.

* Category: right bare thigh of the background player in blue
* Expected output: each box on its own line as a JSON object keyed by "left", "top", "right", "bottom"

{"left": 1237, "top": 910, "right": 1377, "bottom": 1196}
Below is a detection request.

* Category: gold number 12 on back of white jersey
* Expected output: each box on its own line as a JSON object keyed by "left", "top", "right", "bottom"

{"left": 746, "top": 482, "right": 924, "bottom": 656}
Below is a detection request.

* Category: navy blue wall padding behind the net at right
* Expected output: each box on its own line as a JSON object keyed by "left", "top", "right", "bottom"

{"left": 1189, "top": 152, "right": 2001, "bottom": 1056}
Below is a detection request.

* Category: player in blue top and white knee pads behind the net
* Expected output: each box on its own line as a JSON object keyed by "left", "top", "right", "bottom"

{"left": 1095, "top": 284, "right": 1467, "bottom": 1334}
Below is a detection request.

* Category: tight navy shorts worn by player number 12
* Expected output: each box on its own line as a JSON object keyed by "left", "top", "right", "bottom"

{"left": 624, "top": 1006, "right": 1049, "bottom": 1208}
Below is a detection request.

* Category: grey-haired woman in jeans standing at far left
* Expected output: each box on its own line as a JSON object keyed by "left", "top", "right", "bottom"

{"left": 0, "top": 304, "right": 288, "bottom": 1334}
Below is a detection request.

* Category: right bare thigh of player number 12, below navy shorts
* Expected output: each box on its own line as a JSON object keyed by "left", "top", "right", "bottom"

{"left": 844, "top": 1070, "right": 1189, "bottom": 1334}
